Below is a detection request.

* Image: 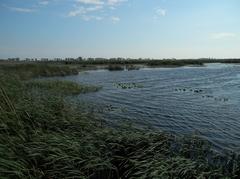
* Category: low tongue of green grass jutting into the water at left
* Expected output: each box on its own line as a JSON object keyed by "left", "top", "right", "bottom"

{"left": 25, "top": 80, "right": 100, "bottom": 95}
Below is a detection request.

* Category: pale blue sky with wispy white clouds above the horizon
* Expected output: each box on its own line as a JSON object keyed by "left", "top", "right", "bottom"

{"left": 0, "top": 0, "right": 240, "bottom": 58}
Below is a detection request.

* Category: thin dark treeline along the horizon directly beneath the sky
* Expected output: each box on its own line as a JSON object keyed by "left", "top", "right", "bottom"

{"left": 0, "top": 57, "right": 240, "bottom": 66}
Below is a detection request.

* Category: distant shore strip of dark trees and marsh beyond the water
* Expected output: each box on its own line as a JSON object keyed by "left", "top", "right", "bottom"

{"left": 0, "top": 58, "right": 240, "bottom": 74}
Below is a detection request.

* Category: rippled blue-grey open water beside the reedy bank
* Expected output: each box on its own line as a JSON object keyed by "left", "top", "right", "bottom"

{"left": 59, "top": 64, "right": 240, "bottom": 152}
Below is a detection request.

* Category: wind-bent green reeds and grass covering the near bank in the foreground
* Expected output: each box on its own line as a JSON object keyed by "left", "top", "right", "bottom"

{"left": 0, "top": 62, "right": 240, "bottom": 179}
